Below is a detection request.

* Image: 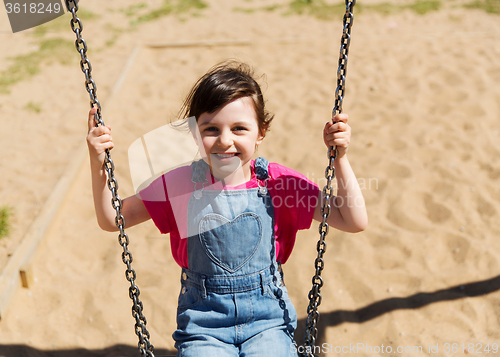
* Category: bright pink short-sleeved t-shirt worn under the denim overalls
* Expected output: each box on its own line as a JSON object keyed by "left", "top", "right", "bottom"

{"left": 139, "top": 161, "right": 319, "bottom": 268}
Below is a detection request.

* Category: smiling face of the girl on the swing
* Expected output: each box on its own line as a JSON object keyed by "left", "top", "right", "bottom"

{"left": 198, "top": 97, "right": 264, "bottom": 182}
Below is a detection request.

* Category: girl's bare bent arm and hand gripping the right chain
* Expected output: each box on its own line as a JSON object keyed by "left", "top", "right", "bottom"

{"left": 314, "top": 114, "right": 368, "bottom": 233}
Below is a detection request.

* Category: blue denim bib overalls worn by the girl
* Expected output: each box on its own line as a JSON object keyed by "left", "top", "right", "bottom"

{"left": 173, "top": 158, "right": 297, "bottom": 357}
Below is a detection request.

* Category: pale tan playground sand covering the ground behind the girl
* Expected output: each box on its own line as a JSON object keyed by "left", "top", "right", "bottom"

{"left": 0, "top": 0, "right": 500, "bottom": 357}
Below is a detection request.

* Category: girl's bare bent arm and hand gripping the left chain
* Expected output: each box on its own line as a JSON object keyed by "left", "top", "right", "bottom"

{"left": 87, "top": 108, "right": 151, "bottom": 232}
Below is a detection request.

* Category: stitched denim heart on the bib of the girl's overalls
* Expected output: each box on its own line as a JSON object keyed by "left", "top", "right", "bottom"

{"left": 199, "top": 212, "right": 262, "bottom": 273}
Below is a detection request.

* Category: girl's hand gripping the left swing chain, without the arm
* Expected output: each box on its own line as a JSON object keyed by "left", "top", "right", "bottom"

{"left": 87, "top": 107, "right": 115, "bottom": 166}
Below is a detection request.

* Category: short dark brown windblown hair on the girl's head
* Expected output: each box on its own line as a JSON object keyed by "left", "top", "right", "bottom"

{"left": 180, "top": 61, "right": 274, "bottom": 135}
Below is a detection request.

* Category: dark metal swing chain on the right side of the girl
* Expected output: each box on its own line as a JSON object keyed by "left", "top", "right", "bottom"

{"left": 301, "top": 0, "right": 356, "bottom": 357}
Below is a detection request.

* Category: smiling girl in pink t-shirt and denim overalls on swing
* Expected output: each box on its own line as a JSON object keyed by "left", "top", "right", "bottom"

{"left": 87, "top": 62, "right": 367, "bottom": 357}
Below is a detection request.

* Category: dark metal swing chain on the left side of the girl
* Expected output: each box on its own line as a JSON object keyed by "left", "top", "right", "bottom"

{"left": 65, "top": 0, "right": 154, "bottom": 357}
